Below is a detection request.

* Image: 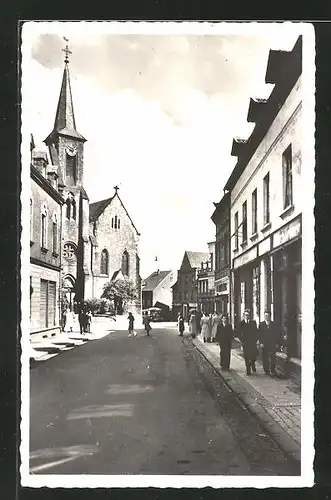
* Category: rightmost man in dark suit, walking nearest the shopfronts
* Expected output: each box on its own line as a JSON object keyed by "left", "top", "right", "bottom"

{"left": 259, "top": 311, "right": 280, "bottom": 376}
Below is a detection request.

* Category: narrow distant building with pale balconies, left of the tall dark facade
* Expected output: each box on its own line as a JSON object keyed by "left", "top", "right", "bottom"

{"left": 197, "top": 242, "right": 215, "bottom": 314}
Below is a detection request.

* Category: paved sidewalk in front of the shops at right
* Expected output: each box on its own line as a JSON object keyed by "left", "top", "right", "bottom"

{"left": 192, "top": 336, "right": 301, "bottom": 460}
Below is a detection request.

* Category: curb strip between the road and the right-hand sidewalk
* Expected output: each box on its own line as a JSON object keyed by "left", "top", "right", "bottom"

{"left": 192, "top": 339, "right": 301, "bottom": 462}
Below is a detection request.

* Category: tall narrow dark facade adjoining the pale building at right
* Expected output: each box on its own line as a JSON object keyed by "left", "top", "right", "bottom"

{"left": 211, "top": 192, "right": 230, "bottom": 315}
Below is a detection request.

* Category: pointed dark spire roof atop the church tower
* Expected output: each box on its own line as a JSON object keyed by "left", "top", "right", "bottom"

{"left": 45, "top": 63, "right": 86, "bottom": 144}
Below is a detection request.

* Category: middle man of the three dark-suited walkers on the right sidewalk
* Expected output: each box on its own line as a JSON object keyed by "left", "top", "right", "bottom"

{"left": 238, "top": 309, "right": 258, "bottom": 375}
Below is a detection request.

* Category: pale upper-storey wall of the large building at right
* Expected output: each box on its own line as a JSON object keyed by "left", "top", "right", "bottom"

{"left": 231, "top": 78, "right": 304, "bottom": 259}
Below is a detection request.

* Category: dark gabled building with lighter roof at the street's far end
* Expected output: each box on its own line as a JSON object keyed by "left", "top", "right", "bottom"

{"left": 173, "top": 251, "right": 209, "bottom": 319}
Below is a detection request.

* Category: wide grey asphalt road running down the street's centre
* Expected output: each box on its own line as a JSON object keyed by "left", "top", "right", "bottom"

{"left": 30, "top": 327, "right": 300, "bottom": 475}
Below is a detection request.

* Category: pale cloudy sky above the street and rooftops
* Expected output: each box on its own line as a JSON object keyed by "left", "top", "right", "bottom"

{"left": 22, "top": 22, "right": 300, "bottom": 278}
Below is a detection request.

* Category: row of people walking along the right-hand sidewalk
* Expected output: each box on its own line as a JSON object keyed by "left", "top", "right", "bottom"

{"left": 178, "top": 309, "right": 279, "bottom": 376}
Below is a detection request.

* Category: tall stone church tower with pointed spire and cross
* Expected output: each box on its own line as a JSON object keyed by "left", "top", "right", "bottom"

{"left": 44, "top": 39, "right": 89, "bottom": 307}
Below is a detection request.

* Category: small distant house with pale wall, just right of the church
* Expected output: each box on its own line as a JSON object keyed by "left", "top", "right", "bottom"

{"left": 142, "top": 269, "right": 177, "bottom": 311}
